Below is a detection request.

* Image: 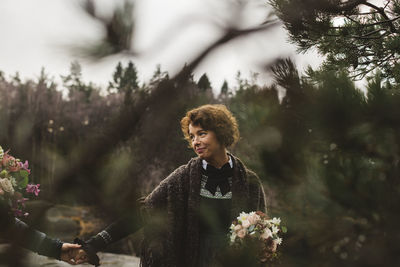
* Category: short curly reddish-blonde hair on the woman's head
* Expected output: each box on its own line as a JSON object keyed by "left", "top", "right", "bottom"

{"left": 181, "top": 104, "right": 240, "bottom": 148}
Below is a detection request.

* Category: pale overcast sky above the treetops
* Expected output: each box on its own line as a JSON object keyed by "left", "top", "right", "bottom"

{"left": 0, "top": 0, "right": 321, "bottom": 94}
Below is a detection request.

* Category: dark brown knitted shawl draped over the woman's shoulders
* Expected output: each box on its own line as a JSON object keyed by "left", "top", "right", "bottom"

{"left": 141, "top": 155, "right": 266, "bottom": 267}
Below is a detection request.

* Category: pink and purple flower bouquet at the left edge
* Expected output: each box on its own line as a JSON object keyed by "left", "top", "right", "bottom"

{"left": 0, "top": 146, "right": 40, "bottom": 217}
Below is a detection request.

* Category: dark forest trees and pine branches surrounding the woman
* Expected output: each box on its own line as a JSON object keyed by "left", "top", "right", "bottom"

{"left": 0, "top": 0, "right": 400, "bottom": 266}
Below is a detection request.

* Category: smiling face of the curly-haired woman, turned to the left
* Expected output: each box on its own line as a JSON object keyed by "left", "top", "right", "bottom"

{"left": 189, "top": 124, "right": 226, "bottom": 162}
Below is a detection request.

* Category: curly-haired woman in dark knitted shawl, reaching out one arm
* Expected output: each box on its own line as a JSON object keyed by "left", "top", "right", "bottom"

{"left": 75, "top": 105, "right": 266, "bottom": 267}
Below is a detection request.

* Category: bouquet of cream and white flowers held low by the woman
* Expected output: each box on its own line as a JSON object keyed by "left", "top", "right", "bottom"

{"left": 229, "top": 211, "right": 287, "bottom": 263}
